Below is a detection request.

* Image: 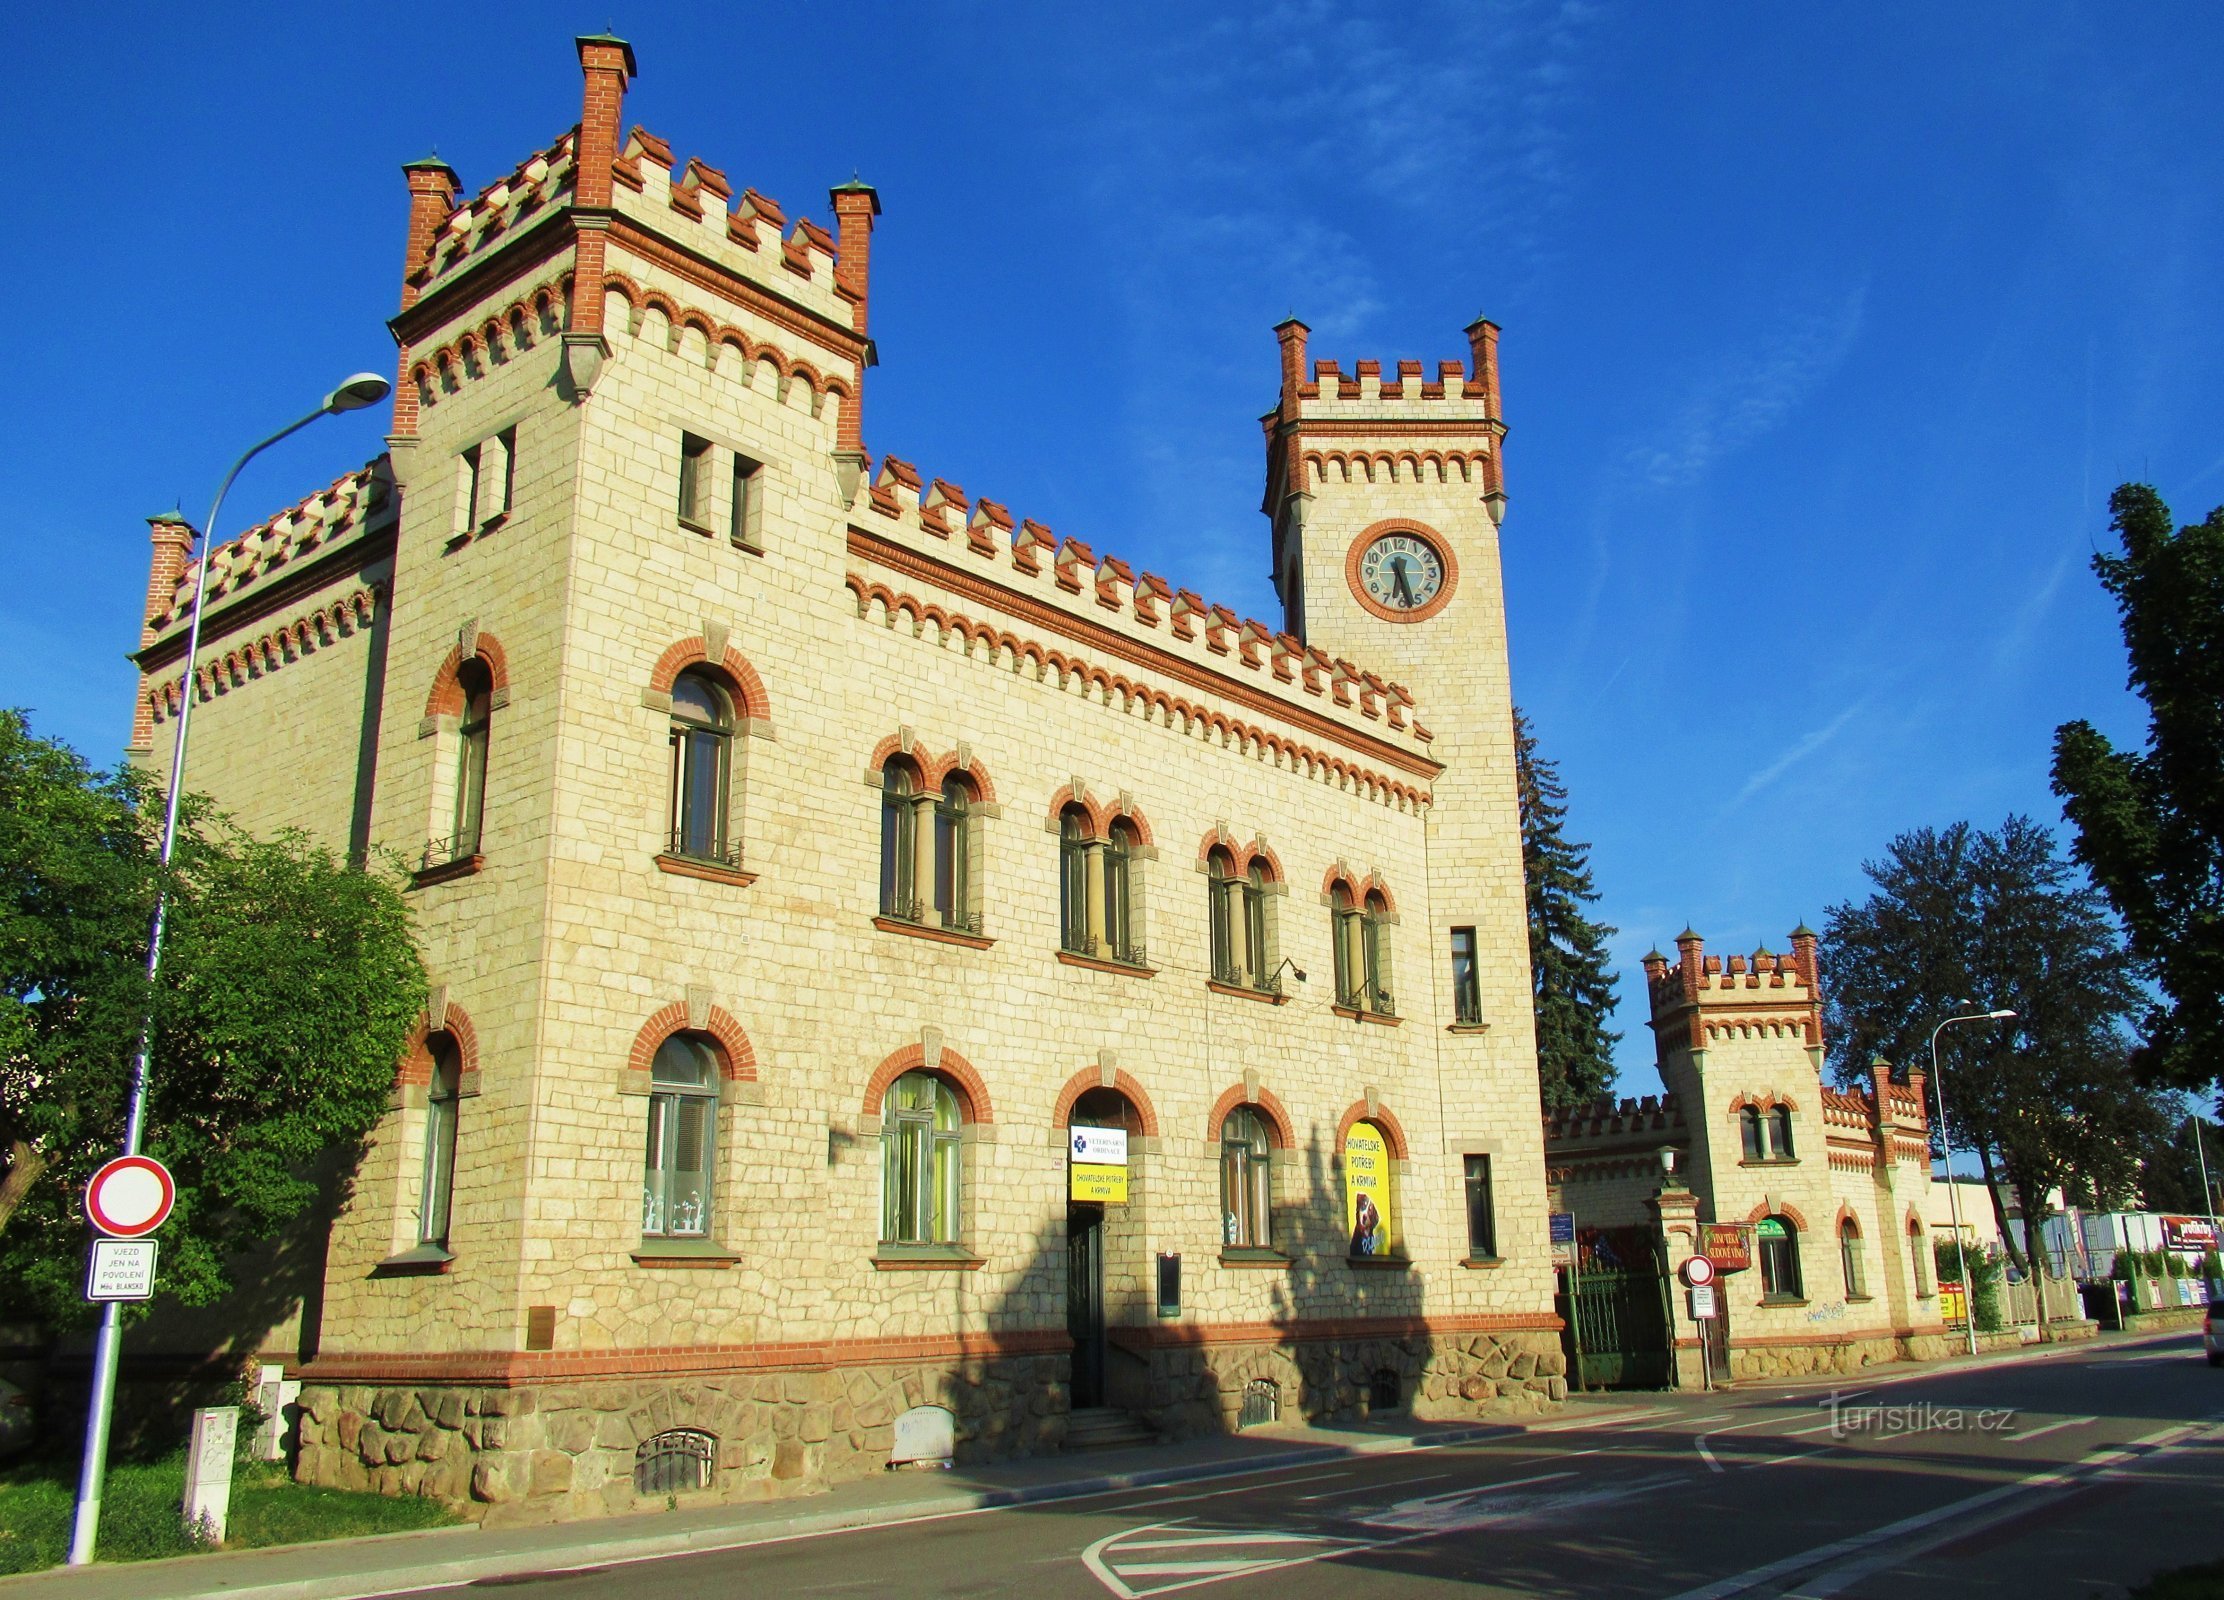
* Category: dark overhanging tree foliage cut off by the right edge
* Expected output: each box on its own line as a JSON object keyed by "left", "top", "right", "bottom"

{"left": 2055, "top": 483, "right": 2224, "bottom": 1108}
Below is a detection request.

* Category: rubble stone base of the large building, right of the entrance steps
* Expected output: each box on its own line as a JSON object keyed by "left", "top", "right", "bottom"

{"left": 1143, "top": 1333, "right": 1568, "bottom": 1438}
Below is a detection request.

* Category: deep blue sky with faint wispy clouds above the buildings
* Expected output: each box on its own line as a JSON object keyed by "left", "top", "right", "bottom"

{"left": 0, "top": 0, "right": 2224, "bottom": 1093}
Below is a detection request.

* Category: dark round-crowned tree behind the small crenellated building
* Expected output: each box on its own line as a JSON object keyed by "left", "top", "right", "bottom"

{"left": 1828, "top": 817, "right": 2162, "bottom": 1266}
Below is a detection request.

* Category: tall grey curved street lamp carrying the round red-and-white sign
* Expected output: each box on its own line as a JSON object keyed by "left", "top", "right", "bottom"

{"left": 69, "top": 372, "right": 394, "bottom": 1567}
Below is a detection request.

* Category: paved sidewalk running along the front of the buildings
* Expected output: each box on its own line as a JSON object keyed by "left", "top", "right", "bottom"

{"left": 0, "top": 1333, "right": 2184, "bottom": 1600}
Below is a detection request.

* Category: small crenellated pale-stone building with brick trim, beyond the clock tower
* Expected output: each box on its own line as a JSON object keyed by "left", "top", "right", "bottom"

{"left": 1546, "top": 926, "right": 1946, "bottom": 1384}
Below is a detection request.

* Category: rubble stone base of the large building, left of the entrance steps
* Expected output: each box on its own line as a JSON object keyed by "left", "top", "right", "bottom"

{"left": 294, "top": 1355, "right": 1068, "bottom": 1524}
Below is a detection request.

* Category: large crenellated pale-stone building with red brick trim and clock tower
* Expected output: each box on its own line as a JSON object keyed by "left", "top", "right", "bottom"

{"left": 136, "top": 36, "right": 1563, "bottom": 1515}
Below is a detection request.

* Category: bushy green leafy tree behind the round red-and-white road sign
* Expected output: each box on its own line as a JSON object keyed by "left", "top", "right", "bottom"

{"left": 0, "top": 710, "right": 425, "bottom": 1320}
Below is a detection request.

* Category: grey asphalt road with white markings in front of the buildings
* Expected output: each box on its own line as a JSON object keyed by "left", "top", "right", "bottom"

{"left": 382, "top": 1337, "right": 2224, "bottom": 1600}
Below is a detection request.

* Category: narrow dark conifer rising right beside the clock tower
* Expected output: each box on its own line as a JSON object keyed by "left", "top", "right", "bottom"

{"left": 1515, "top": 710, "right": 1621, "bottom": 1110}
